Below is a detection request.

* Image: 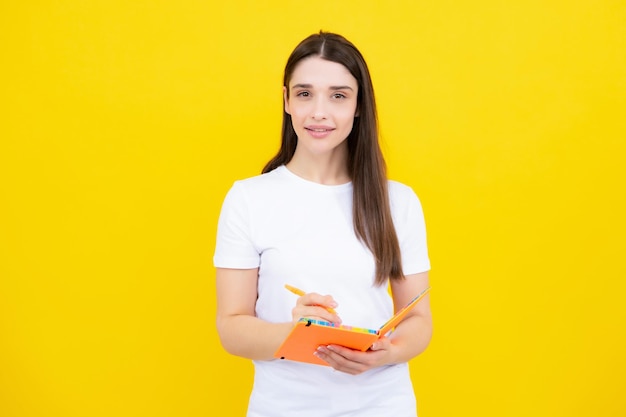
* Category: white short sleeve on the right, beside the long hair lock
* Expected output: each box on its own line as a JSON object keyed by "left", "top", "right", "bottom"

{"left": 390, "top": 183, "right": 430, "bottom": 275}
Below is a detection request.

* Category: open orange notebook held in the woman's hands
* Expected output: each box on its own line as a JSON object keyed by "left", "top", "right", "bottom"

{"left": 274, "top": 287, "right": 430, "bottom": 366}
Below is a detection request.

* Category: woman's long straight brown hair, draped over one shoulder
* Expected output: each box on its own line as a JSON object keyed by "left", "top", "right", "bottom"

{"left": 262, "top": 32, "right": 404, "bottom": 285}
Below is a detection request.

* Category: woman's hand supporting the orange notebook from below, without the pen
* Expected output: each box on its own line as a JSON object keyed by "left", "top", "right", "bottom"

{"left": 315, "top": 337, "right": 393, "bottom": 375}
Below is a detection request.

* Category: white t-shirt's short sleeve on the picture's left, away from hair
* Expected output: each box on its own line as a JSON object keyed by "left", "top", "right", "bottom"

{"left": 213, "top": 182, "right": 260, "bottom": 269}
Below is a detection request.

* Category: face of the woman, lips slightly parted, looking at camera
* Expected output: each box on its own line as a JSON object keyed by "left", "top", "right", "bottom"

{"left": 284, "top": 57, "right": 358, "bottom": 156}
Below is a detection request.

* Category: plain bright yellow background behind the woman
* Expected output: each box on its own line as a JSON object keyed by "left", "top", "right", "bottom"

{"left": 0, "top": 0, "right": 626, "bottom": 417}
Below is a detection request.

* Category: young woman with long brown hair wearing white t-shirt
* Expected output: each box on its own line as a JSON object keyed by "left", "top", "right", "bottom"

{"left": 214, "top": 32, "right": 432, "bottom": 417}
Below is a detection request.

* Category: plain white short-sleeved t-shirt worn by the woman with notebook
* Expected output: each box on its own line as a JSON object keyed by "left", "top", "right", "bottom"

{"left": 214, "top": 166, "right": 430, "bottom": 417}
